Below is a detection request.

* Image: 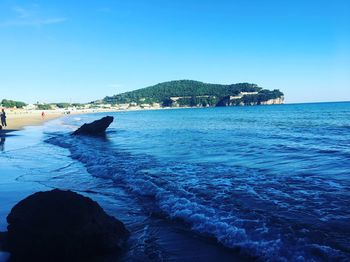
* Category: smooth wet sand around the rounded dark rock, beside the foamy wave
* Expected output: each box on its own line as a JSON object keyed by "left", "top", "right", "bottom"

{"left": 0, "top": 121, "right": 252, "bottom": 261}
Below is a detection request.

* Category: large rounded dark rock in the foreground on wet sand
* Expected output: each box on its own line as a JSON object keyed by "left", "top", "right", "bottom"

{"left": 7, "top": 189, "right": 129, "bottom": 261}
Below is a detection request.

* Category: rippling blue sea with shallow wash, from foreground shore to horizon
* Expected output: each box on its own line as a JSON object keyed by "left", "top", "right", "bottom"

{"left": 0, "top": 102, "right": 350, "bottom": 261}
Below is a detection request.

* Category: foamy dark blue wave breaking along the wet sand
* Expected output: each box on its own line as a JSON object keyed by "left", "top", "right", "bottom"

{"left": 46, "top": 134, "right": 347, "bottom": 261}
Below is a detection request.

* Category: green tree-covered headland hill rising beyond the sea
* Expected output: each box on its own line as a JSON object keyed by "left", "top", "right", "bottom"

{"left": 103, "top": 80, "right": 283, "bottom": 107}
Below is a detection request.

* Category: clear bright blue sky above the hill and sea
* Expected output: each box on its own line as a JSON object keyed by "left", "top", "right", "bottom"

{"left": 0, "top": 0, "right": 350, "bottom": 102}
